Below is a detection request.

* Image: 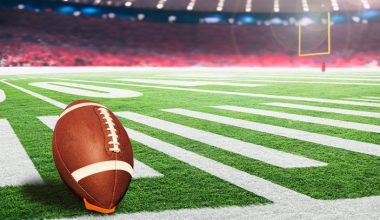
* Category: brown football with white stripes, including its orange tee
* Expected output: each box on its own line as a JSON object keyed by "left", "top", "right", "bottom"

{"left": 53, "top": 100, "right": 133, "bottom": 213}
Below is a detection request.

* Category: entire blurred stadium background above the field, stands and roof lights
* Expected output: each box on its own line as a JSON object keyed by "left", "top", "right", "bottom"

{"left": 0, "top": 0, "right": 380, "bottom": 67}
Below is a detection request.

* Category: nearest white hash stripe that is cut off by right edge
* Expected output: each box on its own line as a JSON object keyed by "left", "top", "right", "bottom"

{"left": 163, "top": 108, "right": 380, "bottom": 156}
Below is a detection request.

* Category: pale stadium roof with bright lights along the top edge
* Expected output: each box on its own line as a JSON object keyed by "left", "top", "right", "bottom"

{"left": 58, "top": 0, "right": 380, "bottom": 13}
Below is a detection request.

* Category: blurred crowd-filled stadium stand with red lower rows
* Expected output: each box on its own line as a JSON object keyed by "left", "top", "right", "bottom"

{"left": 0, "top": 9, "right": 380, "bottom": 67}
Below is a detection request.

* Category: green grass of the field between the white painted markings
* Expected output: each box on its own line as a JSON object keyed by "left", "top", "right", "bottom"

{"left": 0, "top": 69, "right": 380, "bottom": 219}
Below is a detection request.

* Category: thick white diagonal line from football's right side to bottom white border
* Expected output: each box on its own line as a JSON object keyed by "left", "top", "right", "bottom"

{"left": 126, "top": 128, "right": 312, "bottom": 203}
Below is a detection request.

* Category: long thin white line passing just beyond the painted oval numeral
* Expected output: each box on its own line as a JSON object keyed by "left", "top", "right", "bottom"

{"left": 49, "top": 78, "right": 380, "bottom": 107}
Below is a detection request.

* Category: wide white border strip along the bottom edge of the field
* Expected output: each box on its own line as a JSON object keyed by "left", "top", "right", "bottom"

{"left": 67, "top": 196, "right": 380, "bottom": 220}
